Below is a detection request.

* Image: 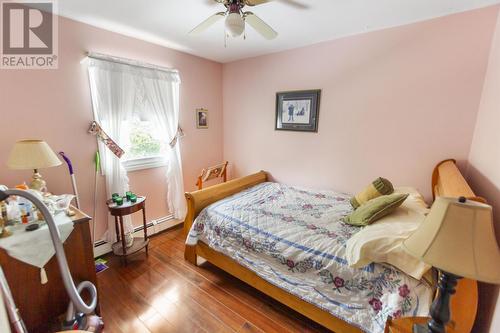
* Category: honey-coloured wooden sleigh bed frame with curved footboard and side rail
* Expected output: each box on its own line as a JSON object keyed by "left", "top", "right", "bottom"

{"left": 184, "top": 159, "right": 485, "bottom": 333}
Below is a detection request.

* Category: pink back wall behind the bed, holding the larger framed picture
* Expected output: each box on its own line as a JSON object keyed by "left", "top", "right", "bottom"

{"left": 223, "top": 7, "right": 497, "bottom": 201}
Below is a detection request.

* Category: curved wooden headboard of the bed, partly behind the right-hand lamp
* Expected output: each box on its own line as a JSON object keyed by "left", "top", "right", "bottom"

{"left": 432, "top": 159, "right": 486, "bottom": 333}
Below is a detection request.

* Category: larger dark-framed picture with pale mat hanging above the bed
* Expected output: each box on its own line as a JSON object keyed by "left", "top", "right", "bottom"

{"left": 275, "top": 90, "right": 321, "bottom": 132}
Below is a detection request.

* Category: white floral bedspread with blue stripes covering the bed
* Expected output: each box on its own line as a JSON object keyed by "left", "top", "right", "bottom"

{"left": 186, "top": 183, "right": 432, "bottom": 333}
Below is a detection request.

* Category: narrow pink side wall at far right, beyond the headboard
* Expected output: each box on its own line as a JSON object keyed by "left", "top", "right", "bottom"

{"left": 468, "top": 5, "right": 500, "bottom": 333}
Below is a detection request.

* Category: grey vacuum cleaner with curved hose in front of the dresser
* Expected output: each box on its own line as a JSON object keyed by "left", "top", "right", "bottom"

{"left": 0, "top": 190, "right": 104, "bottom": 333}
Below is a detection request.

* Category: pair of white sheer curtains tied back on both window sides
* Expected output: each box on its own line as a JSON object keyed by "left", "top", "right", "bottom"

{"left": 88, "top": 58, "right": 187, "bottom": 241}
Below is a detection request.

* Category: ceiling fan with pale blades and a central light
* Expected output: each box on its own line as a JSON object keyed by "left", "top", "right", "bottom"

{"left": 189, "top": 0, "right": 307, "bottom": 40}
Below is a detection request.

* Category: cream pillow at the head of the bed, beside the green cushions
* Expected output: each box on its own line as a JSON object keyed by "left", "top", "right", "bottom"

{"left": 346, "top": 188, "right": 431, "bottom": 280}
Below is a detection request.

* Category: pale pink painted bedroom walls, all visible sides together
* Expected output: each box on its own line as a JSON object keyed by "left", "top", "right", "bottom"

{"left": 0, "top": 7, "right": 500, "bottom": 332}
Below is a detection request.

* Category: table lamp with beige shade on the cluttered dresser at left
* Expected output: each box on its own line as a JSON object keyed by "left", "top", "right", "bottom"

{"left": 7, "top": 140, "right": 61, "bottom": 191}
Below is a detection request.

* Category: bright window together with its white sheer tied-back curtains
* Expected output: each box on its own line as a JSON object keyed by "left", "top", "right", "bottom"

{"left": 87, "top": 53, "right": 186, "bottom": 220}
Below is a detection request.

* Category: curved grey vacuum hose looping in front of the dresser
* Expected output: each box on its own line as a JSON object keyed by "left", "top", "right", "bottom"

{"left": 0, "top": 190, "right": 97, "bottom": 314}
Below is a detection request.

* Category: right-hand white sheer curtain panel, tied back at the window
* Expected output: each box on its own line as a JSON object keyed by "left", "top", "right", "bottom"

{"left": 143, "top": 72, "right": 187, "bottom": 220}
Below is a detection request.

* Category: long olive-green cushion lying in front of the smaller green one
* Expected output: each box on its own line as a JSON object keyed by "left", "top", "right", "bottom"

{"left": 343, "top": 193, "right": 408, "bottom": 226}
